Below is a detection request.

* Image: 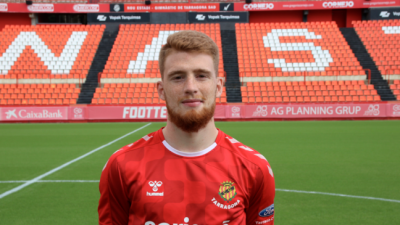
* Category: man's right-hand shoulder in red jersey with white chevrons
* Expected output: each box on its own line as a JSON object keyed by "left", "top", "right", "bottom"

{"left": 219, "top": 131, "right": 269, "bottom": 170}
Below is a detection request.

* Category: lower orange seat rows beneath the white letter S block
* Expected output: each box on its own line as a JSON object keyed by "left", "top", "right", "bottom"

{"left": 241, "top": 80, "right": 381, "bottom": 103}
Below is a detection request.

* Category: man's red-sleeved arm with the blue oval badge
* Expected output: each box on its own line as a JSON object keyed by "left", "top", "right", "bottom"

{"left": 246, "top": 162, "right": 275, "bottom": 225}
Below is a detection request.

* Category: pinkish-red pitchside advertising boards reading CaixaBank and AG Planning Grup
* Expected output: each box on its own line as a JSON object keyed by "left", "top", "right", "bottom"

{"left": 0, "top": 102, "right": 400, "bottom": 122}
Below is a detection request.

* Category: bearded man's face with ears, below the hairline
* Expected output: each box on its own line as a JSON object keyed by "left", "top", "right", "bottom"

{"left": 157, "top": 51, "right": 222, "bottom": 132}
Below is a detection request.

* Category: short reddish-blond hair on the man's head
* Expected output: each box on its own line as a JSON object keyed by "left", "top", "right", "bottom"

{"left": 158, "top": 30, "right": 219, "bottom": 78}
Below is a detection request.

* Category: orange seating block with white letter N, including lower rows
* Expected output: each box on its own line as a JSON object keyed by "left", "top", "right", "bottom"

{"left": 0, "top": 25, "right": 105, "bottom": 105}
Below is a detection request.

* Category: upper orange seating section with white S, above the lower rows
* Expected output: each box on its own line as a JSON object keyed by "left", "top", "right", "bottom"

{"left": 236, "top": 22, "right": 366, "bottom": 82}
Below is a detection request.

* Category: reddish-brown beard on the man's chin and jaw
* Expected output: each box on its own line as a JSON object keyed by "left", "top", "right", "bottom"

{"left": 166, "top": 96, "right": 215, "bottom": 133}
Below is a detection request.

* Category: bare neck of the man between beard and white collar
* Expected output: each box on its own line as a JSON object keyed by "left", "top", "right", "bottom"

{"left": 163, "top": 118, "right": 218, "bottom": 152}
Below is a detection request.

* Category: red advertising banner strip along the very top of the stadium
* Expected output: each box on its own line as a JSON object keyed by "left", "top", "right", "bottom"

{"left": 0, "top": 0, "right": 400, "bottom": 13}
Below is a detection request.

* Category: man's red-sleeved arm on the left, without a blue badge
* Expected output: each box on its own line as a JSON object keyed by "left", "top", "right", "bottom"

{"left": 98, "top": 156, "right": 130, "bottom": 225}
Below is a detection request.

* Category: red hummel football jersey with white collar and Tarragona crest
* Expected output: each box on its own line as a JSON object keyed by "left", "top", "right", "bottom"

{"left": 98, "top": 129, "right": 275, "bottom": 225}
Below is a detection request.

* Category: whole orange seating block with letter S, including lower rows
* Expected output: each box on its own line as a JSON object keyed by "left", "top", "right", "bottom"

{"left": 236, "top": 22, "right": 381, "bottom": 103}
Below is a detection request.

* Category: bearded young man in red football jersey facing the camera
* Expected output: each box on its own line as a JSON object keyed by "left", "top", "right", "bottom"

{"left": 98, "top": 31, "right": 275, "bottom": 225}
